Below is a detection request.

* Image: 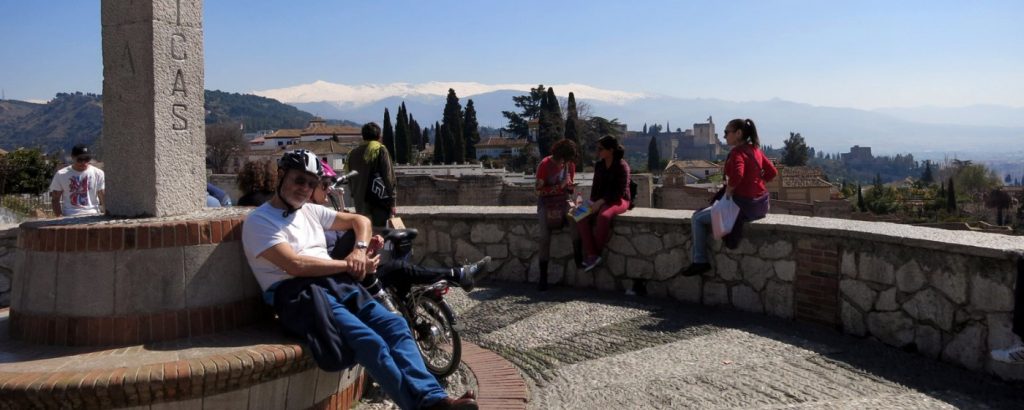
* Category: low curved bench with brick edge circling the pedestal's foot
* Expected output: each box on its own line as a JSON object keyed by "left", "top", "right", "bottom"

{"left": 0, "top": 315, "right": 366, "bottom": 409}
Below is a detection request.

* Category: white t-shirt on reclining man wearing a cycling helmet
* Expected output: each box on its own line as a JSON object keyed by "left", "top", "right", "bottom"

{"left": 242, "top": 201, "right": 338, "bottom": 291}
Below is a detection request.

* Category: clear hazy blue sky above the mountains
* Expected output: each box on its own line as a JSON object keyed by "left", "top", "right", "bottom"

{"left": 0, "top": 0, "right": 1024, "bottom": 109}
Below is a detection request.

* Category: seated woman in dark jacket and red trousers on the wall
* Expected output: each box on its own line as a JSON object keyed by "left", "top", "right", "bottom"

{"left": 577, "top": 135, "right": 630, "bottom": 272}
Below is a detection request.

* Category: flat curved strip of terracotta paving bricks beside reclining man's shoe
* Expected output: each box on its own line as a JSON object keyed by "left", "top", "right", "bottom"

{"left": 462, "top": 340, "right": 529, "bottom": 409}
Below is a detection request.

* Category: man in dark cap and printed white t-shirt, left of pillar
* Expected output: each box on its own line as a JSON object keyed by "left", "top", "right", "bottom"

{"left": 50, "top": 145, "right": 104, "bottom": 216}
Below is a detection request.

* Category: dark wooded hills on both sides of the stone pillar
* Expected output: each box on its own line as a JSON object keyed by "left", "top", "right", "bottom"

{"left": 0, "top": 90, "right": 321, "bottom": 155}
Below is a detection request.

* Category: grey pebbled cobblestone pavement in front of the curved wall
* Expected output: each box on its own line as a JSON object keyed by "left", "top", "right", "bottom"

{"left": 358, "top": 283, "right": 1024, "bottom": 409}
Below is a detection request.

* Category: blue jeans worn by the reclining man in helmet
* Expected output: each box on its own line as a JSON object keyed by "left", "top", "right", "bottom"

{"left": 328, "top": 295, "right": 447, "bottom": 409}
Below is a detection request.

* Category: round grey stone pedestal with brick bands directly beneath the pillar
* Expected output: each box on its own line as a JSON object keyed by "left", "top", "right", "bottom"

{"left": 11, "top": 208, "right": 270, "bottom": 346}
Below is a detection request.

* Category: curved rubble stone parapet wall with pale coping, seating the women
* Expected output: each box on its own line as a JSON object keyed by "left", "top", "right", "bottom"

{"left": 402, "top": 207, "right": 1024, "bottom": 378}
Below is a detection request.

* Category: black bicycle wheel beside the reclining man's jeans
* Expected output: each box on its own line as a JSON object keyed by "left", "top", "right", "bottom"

{"left": 414, "top": 297, "right": 462, "bottom": 378}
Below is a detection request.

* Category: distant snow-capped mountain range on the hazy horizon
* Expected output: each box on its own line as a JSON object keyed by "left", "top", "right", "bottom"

{"left": 252, "top": 81, "right": 1024, "bottom": 154}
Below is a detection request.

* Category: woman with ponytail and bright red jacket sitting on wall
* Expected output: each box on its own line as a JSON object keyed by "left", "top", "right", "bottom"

{"left": 683, "top": 118, "right": 778, "bottom": 276}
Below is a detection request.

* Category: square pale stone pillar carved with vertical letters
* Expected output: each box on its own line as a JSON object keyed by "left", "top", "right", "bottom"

{"left": 101, "top": 0, "right": 206, "bottom": 217}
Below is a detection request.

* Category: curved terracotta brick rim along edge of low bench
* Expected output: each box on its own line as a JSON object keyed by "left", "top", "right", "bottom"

{"left": 0, "top": 344, "right": 367, "bottom": 409}
